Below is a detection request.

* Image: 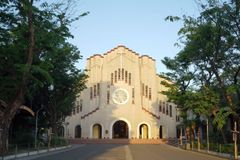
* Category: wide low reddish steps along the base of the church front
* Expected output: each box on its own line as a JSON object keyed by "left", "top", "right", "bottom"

{"left": 69, "top": 138, "right": 167, "bottom": 144}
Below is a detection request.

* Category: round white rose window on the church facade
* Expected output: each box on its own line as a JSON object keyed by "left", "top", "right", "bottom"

{"left": 112, "top": 88, "right": 129, "bottom": 104}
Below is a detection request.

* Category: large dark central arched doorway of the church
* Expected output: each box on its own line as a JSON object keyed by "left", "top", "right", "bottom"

{"left": 112, "top": 120, "right": 128, "bottom": 138}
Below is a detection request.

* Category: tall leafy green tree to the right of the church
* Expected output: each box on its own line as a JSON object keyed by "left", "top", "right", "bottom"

{"left": 163, "top": 0, "right": 240, "bottom": 142}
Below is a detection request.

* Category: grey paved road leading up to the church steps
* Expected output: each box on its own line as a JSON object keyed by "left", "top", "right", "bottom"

{"left": 21, "top": 144, "right": 226, "bottom": 160}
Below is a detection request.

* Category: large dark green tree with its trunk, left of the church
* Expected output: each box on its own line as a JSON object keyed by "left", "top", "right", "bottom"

{"left": 0, "top": 0, "right": 87, "bottom": 153}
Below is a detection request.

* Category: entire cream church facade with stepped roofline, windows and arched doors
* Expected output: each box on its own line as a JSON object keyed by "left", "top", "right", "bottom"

{"left": 65, "top": 46, "right": 179, "bottom": 139}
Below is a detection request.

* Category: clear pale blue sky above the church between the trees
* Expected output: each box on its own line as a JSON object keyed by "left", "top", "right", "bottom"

{"left": 69, "top": 0, "right": 199, "bottom": 73}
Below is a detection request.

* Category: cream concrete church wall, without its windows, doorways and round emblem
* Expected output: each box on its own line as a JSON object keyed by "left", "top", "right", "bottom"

{"left": 65, "top": 46, "right": 179, "bottom": 138}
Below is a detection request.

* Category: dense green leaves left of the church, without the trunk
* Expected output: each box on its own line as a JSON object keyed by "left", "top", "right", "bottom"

{"left": 0, "top": 1, "right": 89, "bottom": 136}
